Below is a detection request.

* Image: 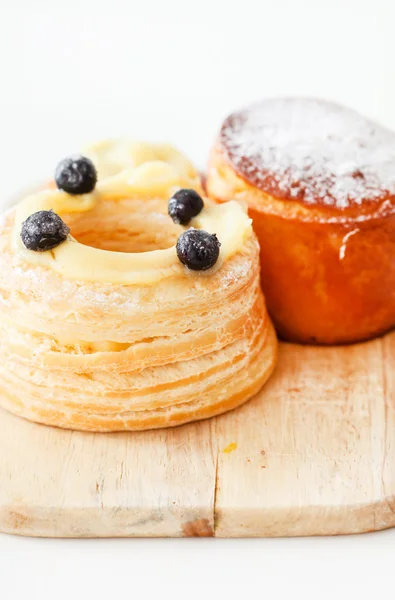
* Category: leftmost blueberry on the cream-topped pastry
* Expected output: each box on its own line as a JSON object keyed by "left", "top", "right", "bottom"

{"left": 21, "top": 210, "right": 70, "bottom": 252}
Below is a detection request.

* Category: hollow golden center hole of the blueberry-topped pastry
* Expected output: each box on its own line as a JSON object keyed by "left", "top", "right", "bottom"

{"left": 62, "top": 199, "right": 184, "bottom": 252}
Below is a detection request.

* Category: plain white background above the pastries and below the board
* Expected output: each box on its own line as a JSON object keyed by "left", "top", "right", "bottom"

{"left": 0, "top": 0, "right": 395, "bottom": 600}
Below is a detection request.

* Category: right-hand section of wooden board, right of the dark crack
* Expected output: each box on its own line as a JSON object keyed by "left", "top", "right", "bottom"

{"left": 215, "top": 336, "right": 395, "bottom": 536}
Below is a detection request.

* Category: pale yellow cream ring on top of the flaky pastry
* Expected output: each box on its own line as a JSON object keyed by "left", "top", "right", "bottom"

{"left": 12, "top": 140, "right": 252, "bottom": 285}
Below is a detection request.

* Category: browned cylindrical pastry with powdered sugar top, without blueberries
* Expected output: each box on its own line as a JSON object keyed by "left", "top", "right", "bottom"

{"left": 207, "top": 98, "right": 395, "bottom": 344}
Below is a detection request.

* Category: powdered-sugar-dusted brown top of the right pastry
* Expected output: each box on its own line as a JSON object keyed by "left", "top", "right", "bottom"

{"left": 220, "top": 98, "right": 395, "bottom": 209}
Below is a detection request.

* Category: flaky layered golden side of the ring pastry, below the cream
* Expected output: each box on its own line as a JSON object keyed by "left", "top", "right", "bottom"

{"left": 0, "top": 141, "right": 277, "bottom": 432}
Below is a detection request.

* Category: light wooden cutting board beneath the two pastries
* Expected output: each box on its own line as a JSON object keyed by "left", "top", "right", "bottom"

{"left": 0, "top": 333, "right": 395, "bottom": 537}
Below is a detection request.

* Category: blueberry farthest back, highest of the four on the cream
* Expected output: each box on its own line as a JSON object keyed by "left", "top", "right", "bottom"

{"left": 55, "top": 156, "right": 97, "bottom": 194}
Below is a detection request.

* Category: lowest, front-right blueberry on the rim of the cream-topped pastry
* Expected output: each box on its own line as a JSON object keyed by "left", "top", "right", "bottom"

{"left": 176, "top": 229, "right": 221, "bottom": 271}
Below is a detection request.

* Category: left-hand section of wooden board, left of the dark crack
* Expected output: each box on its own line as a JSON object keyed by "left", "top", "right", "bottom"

{"left": 0, "top": 411, "right": 215, "bottom": 537}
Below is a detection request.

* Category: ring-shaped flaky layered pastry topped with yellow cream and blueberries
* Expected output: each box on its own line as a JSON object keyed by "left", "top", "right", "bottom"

{"left": 0, "top": 140, "right": 277, "bottom": 432}
